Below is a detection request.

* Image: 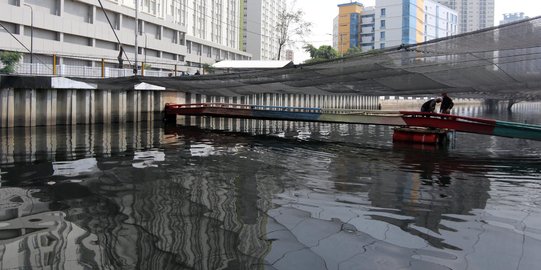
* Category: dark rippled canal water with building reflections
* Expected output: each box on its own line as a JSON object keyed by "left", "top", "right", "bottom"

{"left": 0, "top": 104, "right": 541, "bottom": 270}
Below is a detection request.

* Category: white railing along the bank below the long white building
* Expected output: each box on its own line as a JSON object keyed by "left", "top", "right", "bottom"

{"left": 0, "top": 63, "right": 186, "bottom": 78}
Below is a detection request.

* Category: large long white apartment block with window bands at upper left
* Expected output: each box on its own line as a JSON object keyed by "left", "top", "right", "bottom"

{"left": 0, "top": 0, "right": 251, "bottom": 73}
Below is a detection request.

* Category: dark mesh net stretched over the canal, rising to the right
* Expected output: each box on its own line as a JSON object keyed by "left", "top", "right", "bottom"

{"left": 78, "top": 17, "right": 541, "bottom": 101}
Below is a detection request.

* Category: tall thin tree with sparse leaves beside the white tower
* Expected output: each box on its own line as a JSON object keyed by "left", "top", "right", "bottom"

{"left": 276, "top": 3, "right": 312, "bottom": 60}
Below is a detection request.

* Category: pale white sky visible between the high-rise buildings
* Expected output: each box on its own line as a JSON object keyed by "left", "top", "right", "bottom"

{"left": 287, "top": 0, "right": 541, "bottom": 63}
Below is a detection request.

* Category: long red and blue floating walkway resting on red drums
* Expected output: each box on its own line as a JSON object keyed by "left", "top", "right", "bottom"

{"left": 164, "top": 103, "right": 541, "bottom": 142}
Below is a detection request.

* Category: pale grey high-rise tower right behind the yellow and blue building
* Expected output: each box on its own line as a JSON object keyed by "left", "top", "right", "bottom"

{"left": 437, "top": 0, "right": 495, "bottom": 33}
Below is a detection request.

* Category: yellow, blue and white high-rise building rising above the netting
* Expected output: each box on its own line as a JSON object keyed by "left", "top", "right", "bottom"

{"left": 333, "top": 0, "right": 458, "bottom": 53}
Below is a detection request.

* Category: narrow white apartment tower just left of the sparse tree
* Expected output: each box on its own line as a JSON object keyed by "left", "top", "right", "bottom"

{"left": 242, "top": 0, "right": 286, "bottom": 60}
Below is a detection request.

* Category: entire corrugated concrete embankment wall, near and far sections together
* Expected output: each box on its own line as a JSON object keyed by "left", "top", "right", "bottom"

{"left": 0, "top": 78, "right": 380, "bottom": 128}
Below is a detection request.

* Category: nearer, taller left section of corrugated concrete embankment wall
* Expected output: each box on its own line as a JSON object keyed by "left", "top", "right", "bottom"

{"left": 0, "top": 88, "right": 185, "bottom": 128}
